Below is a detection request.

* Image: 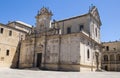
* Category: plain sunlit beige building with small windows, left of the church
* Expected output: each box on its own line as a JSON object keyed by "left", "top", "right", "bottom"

{"left": 0, "top": 21, "right": 31, "bottom": 67}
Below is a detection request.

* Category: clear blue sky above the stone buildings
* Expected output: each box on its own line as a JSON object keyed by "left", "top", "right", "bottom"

{"left": 0, "top": 0, "right": 120, "bottom": 42}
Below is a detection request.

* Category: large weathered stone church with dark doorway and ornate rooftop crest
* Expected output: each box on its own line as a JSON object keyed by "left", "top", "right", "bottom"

{"left": 19, "top": 6, "right": 101, "bottom": 71}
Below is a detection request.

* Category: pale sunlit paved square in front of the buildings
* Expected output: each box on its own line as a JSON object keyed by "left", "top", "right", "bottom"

{"left": 0, "top": 68, "right": 120, "bottom": 78}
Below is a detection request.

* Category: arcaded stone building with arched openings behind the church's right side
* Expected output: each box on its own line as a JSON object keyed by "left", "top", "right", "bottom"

{"left": 102, "top": 41, "right": 120, "bottom": 71}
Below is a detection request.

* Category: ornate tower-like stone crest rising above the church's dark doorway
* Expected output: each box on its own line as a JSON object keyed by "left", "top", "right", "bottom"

{"left": 36, "top": 7, "right": 53, "bottom": 32}
